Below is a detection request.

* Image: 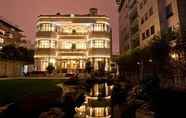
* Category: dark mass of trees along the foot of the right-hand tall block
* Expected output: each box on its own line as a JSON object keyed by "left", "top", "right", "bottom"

{"left": 119, "top": 29, "right": 180, "bottom": 79}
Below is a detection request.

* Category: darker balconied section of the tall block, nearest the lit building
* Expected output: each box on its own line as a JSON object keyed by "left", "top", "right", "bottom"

{"left": 118, "top": 0, "right": 139, "bottom": 54}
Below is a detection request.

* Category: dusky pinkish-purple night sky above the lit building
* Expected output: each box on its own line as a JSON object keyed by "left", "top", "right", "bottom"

{"left": 0, "top": 0, "right": 119, "bottom": 53}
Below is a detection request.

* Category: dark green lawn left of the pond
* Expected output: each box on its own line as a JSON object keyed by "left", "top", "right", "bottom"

{"left": 0, "top": 79, "right": 62, "bottom": 104}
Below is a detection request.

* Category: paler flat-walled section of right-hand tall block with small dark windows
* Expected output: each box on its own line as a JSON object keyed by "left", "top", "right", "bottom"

{"left": 138, "top": 0, "right": 186, "bottom": 47}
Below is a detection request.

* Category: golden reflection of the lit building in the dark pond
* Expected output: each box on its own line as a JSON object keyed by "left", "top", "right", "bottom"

{"left": 76, "top": 82, "right": 113, "bottom": 118}
